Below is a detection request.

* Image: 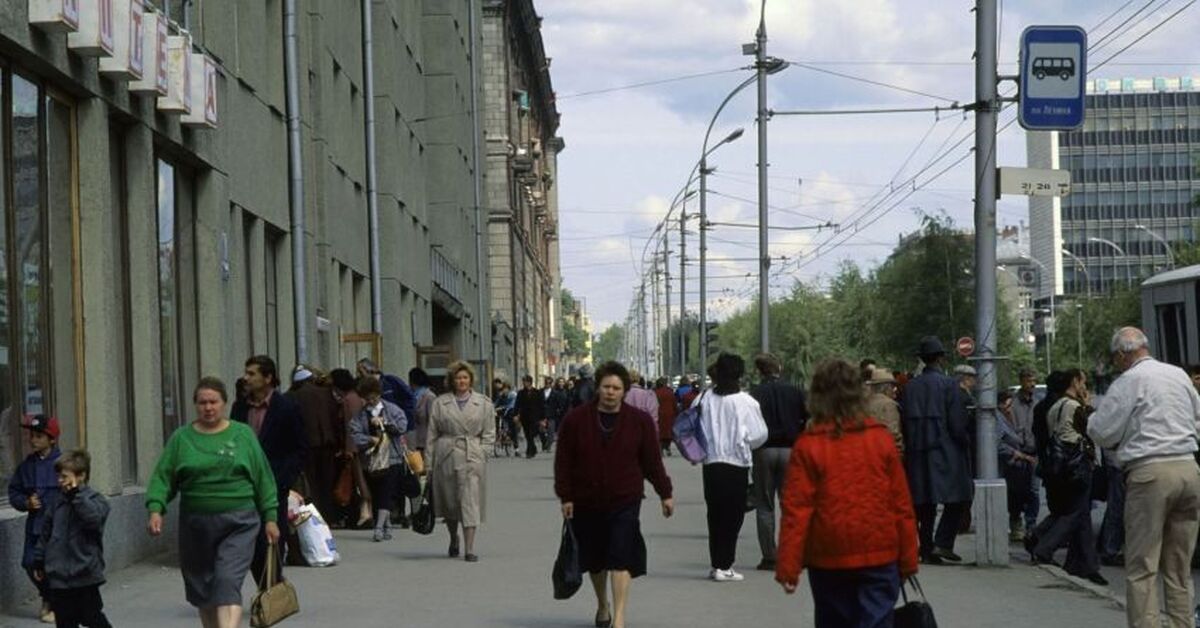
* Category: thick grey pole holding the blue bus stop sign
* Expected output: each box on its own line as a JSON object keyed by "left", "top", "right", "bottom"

{"left": 972, "top": 0, "right": 1008, "bottom": 566}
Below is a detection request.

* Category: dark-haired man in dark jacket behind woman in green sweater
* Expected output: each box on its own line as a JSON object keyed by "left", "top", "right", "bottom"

{"left": 229, "top": 355, "right": 308, "bottom": 581}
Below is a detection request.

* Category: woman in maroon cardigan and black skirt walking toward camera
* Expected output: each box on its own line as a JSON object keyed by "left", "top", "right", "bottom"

{"left": 554, "top": 361, "right": 674, "bottom": 628}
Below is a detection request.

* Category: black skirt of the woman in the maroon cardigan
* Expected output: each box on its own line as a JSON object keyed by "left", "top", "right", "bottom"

{"left": 571, "top": 501, "right": 646, "bottom": 578}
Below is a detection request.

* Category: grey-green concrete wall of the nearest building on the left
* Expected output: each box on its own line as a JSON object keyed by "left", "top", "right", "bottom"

{"left": 0, "top": 0, "right": 491, "bottom": 609}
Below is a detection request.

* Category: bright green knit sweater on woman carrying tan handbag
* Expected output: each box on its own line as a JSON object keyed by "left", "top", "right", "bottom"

{"left": 146, "top": 421, "right": 278, "bottom": 521}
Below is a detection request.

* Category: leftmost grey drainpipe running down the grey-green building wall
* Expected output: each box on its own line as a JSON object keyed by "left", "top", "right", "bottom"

{"left": 283, "top": 0, "right": 308, "bottom": 363}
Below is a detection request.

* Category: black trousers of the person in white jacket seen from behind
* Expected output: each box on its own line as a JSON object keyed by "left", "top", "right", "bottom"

{"left": 702, "top": 462, "right": 750, "bottom": 569}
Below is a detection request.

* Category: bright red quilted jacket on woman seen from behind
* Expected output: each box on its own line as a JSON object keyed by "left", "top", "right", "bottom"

{"left": 775, "top": 419, "right": 917, "bottom": 585}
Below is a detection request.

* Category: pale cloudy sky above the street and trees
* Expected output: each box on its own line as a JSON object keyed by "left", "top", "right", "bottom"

{"left": 535, "top": 0, "right": 1200, "bottom": 331}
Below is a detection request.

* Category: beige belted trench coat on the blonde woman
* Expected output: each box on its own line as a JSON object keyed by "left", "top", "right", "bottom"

{"left": 426, "top": 393, "right": 496, "bottom": 527}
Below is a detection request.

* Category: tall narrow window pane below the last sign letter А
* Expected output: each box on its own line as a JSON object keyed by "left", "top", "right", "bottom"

{"left": 157, "top": 160, "right": 182, "bottom": 437}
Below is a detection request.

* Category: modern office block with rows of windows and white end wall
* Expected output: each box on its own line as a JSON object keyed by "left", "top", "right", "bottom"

{"left": 1026, "top": 77, "right": 1200, "bottom": 304}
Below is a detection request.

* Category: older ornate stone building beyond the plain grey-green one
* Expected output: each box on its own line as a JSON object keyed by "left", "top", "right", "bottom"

{"left": 482, "top": 0, "right": 564, "bottom": 381}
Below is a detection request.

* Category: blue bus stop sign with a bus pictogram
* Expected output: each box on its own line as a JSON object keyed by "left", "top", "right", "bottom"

{"left": 1018, "top": 26, "right": 1087, "bottom": 131}
